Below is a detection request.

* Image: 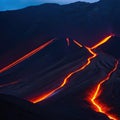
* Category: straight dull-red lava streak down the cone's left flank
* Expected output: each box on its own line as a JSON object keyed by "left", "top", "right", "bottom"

{"left": 0, "top": 39, "right": 54, "bottom": 73}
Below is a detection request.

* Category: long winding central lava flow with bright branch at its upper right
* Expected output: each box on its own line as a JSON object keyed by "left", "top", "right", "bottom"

{"left": 29, "top": 35, "right": 113, "bottom": 103}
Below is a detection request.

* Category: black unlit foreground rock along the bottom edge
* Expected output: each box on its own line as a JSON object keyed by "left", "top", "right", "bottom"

{"left": 0, "top": 94, "right": 108, "bottom": 120}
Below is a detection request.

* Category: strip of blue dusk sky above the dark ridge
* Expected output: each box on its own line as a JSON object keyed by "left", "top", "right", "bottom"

{"left": 0, "top": 0, "right": 99, "bottom": 11}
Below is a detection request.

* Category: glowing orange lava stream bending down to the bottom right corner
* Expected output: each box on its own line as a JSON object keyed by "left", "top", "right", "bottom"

{"left": 88, "top": 61, "right": 119, "bottom": 120}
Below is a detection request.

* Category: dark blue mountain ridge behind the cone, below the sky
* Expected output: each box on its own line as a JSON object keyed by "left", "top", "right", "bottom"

{"left": 0, "top": 0, "right": 120, "bottom": 66}
